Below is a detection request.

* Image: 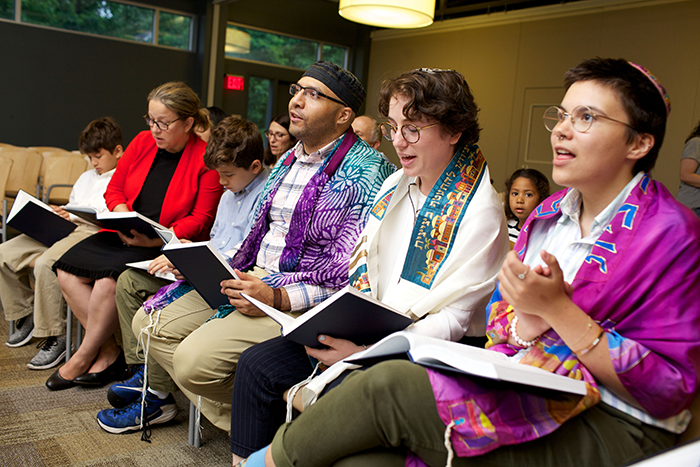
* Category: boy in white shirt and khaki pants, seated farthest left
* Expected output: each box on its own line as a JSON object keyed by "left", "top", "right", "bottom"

{"left": 0, "top": 117, "right": 124, "bottom": 370}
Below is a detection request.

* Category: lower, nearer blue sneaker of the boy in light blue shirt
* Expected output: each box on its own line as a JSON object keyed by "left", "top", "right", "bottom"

{"left": 97, "top": 392, "right": 177, "bottom": 434}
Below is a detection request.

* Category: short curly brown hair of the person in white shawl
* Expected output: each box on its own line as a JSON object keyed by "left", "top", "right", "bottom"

{"left": 379, "top": 68, "right": 481, "bottom": 146}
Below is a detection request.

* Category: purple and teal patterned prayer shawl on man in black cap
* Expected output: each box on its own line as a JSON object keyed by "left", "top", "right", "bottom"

{"left": 143, "top": 129, "right": 396, "bottom": 312}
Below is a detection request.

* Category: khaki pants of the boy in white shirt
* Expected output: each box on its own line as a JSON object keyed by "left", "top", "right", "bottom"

{"left": 0, "top": 225, "right": 98, "bottom": 337}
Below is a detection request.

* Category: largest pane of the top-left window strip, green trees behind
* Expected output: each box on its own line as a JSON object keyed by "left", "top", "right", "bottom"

{"left": 22, "top": 0, "right": 155, "bottom": 42}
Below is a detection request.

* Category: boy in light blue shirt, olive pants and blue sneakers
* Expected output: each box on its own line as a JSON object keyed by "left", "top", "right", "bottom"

{"left": 98, "top": 117, "right": 269, "bottom": 433}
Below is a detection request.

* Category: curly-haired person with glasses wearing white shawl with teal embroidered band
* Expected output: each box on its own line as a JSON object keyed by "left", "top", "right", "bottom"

{"left": 231, "top": 69, "right": 510, "bottom": 465}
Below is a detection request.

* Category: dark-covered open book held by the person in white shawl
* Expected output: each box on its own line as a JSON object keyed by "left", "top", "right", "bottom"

{"left": 241, "top": 286, "right": 413, "bottom": 348}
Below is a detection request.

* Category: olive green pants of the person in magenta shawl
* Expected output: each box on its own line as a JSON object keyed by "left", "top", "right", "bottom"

{"left": 271, "top": 360, "right": 676, "bottom": 467}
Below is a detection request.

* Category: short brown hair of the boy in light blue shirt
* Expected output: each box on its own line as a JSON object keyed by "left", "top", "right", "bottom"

{"left": 204, "top": 117, "right": 263, "bottom": 169}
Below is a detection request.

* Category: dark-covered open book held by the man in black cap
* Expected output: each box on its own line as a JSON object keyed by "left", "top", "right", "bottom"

{"left": 163, "top": 242, "right": 238, "bottom": 309}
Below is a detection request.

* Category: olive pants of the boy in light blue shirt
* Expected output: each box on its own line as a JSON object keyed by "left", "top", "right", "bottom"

{"left": 116, "top": 269, "right": 177, "bottom": 392}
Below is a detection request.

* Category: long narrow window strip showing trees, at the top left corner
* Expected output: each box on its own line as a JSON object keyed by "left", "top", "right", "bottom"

{"left": 8, "top": 0, "right": 193, "bottom": 50}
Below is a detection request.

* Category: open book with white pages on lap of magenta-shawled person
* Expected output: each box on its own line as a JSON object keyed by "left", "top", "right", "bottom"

{"left": 345, "top": 332, "right": 586, "bottom": 395}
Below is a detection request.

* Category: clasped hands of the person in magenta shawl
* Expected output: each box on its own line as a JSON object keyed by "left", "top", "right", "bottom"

{"left": 498, "top": 250, "right": 573, "bottom": 340}
